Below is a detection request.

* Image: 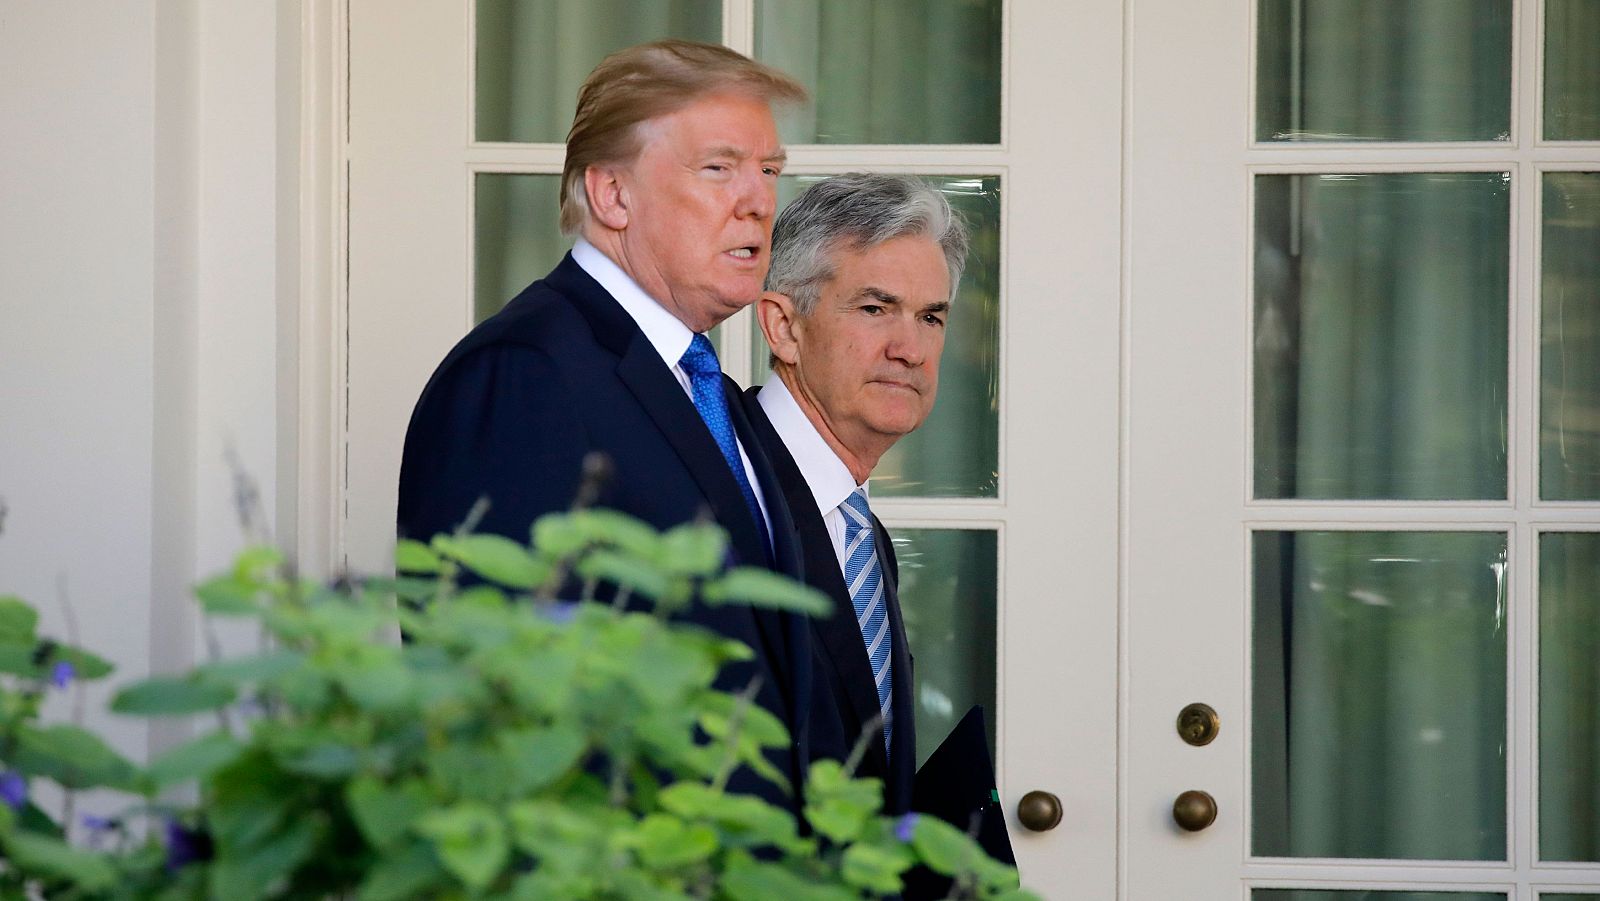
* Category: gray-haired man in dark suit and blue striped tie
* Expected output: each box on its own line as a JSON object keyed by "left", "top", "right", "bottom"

{"left": 732, "top": 173, "right": 968, "bottom": 813}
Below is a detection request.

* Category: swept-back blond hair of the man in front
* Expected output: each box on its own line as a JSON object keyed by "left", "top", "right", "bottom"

{"left": 562, "top": 38, "right": 806, "bottom": 235}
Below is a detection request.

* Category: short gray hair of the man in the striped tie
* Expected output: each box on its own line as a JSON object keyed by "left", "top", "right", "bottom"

{"left": 766, "top": 173, "right": 970, "bottom": 315}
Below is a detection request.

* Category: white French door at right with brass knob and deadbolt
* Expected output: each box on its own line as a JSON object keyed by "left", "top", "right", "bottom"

{"left": 1120, "top": 0, "right": 1600, "bottom": 901}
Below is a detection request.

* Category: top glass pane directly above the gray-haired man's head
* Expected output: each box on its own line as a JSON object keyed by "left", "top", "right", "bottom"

{"left": 755, "top": 0, "right": 1003, "bottom": 144}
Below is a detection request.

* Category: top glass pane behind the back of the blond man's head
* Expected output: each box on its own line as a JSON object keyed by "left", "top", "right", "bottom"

{"left": 474, "top": 0, "right": 722, "bottom": 142}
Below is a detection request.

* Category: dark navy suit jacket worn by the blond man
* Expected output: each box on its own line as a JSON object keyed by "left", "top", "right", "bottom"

{"left": 388, "top": 254, "right": 813, "bottom": 813}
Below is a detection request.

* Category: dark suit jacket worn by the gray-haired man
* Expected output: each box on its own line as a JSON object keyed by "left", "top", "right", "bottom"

{"left": 732, "top": 387, "right": 917, "bottom": 815}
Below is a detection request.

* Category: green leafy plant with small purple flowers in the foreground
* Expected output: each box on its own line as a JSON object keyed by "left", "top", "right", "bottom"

{"left": 0, "top": 509, "right": 1032, "bottom": 901}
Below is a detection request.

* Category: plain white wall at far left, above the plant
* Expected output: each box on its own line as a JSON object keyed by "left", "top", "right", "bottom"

{"left": 0, "top": 0, "right": 299, "bottom": 768}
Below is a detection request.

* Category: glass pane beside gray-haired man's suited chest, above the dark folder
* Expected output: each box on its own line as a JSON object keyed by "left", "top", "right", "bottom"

{"left": 896, "top": 528, "right": 998, "bottom": 767}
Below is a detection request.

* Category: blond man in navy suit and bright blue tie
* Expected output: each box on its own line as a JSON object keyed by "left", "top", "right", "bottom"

{"left": 398, "top": 40, "right": 811, "bottom": 810}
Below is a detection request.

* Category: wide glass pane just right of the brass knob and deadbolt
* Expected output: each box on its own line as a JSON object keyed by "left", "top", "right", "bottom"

{"left": 1251, "top": 531, "right": 1506, "bottom": 861}
